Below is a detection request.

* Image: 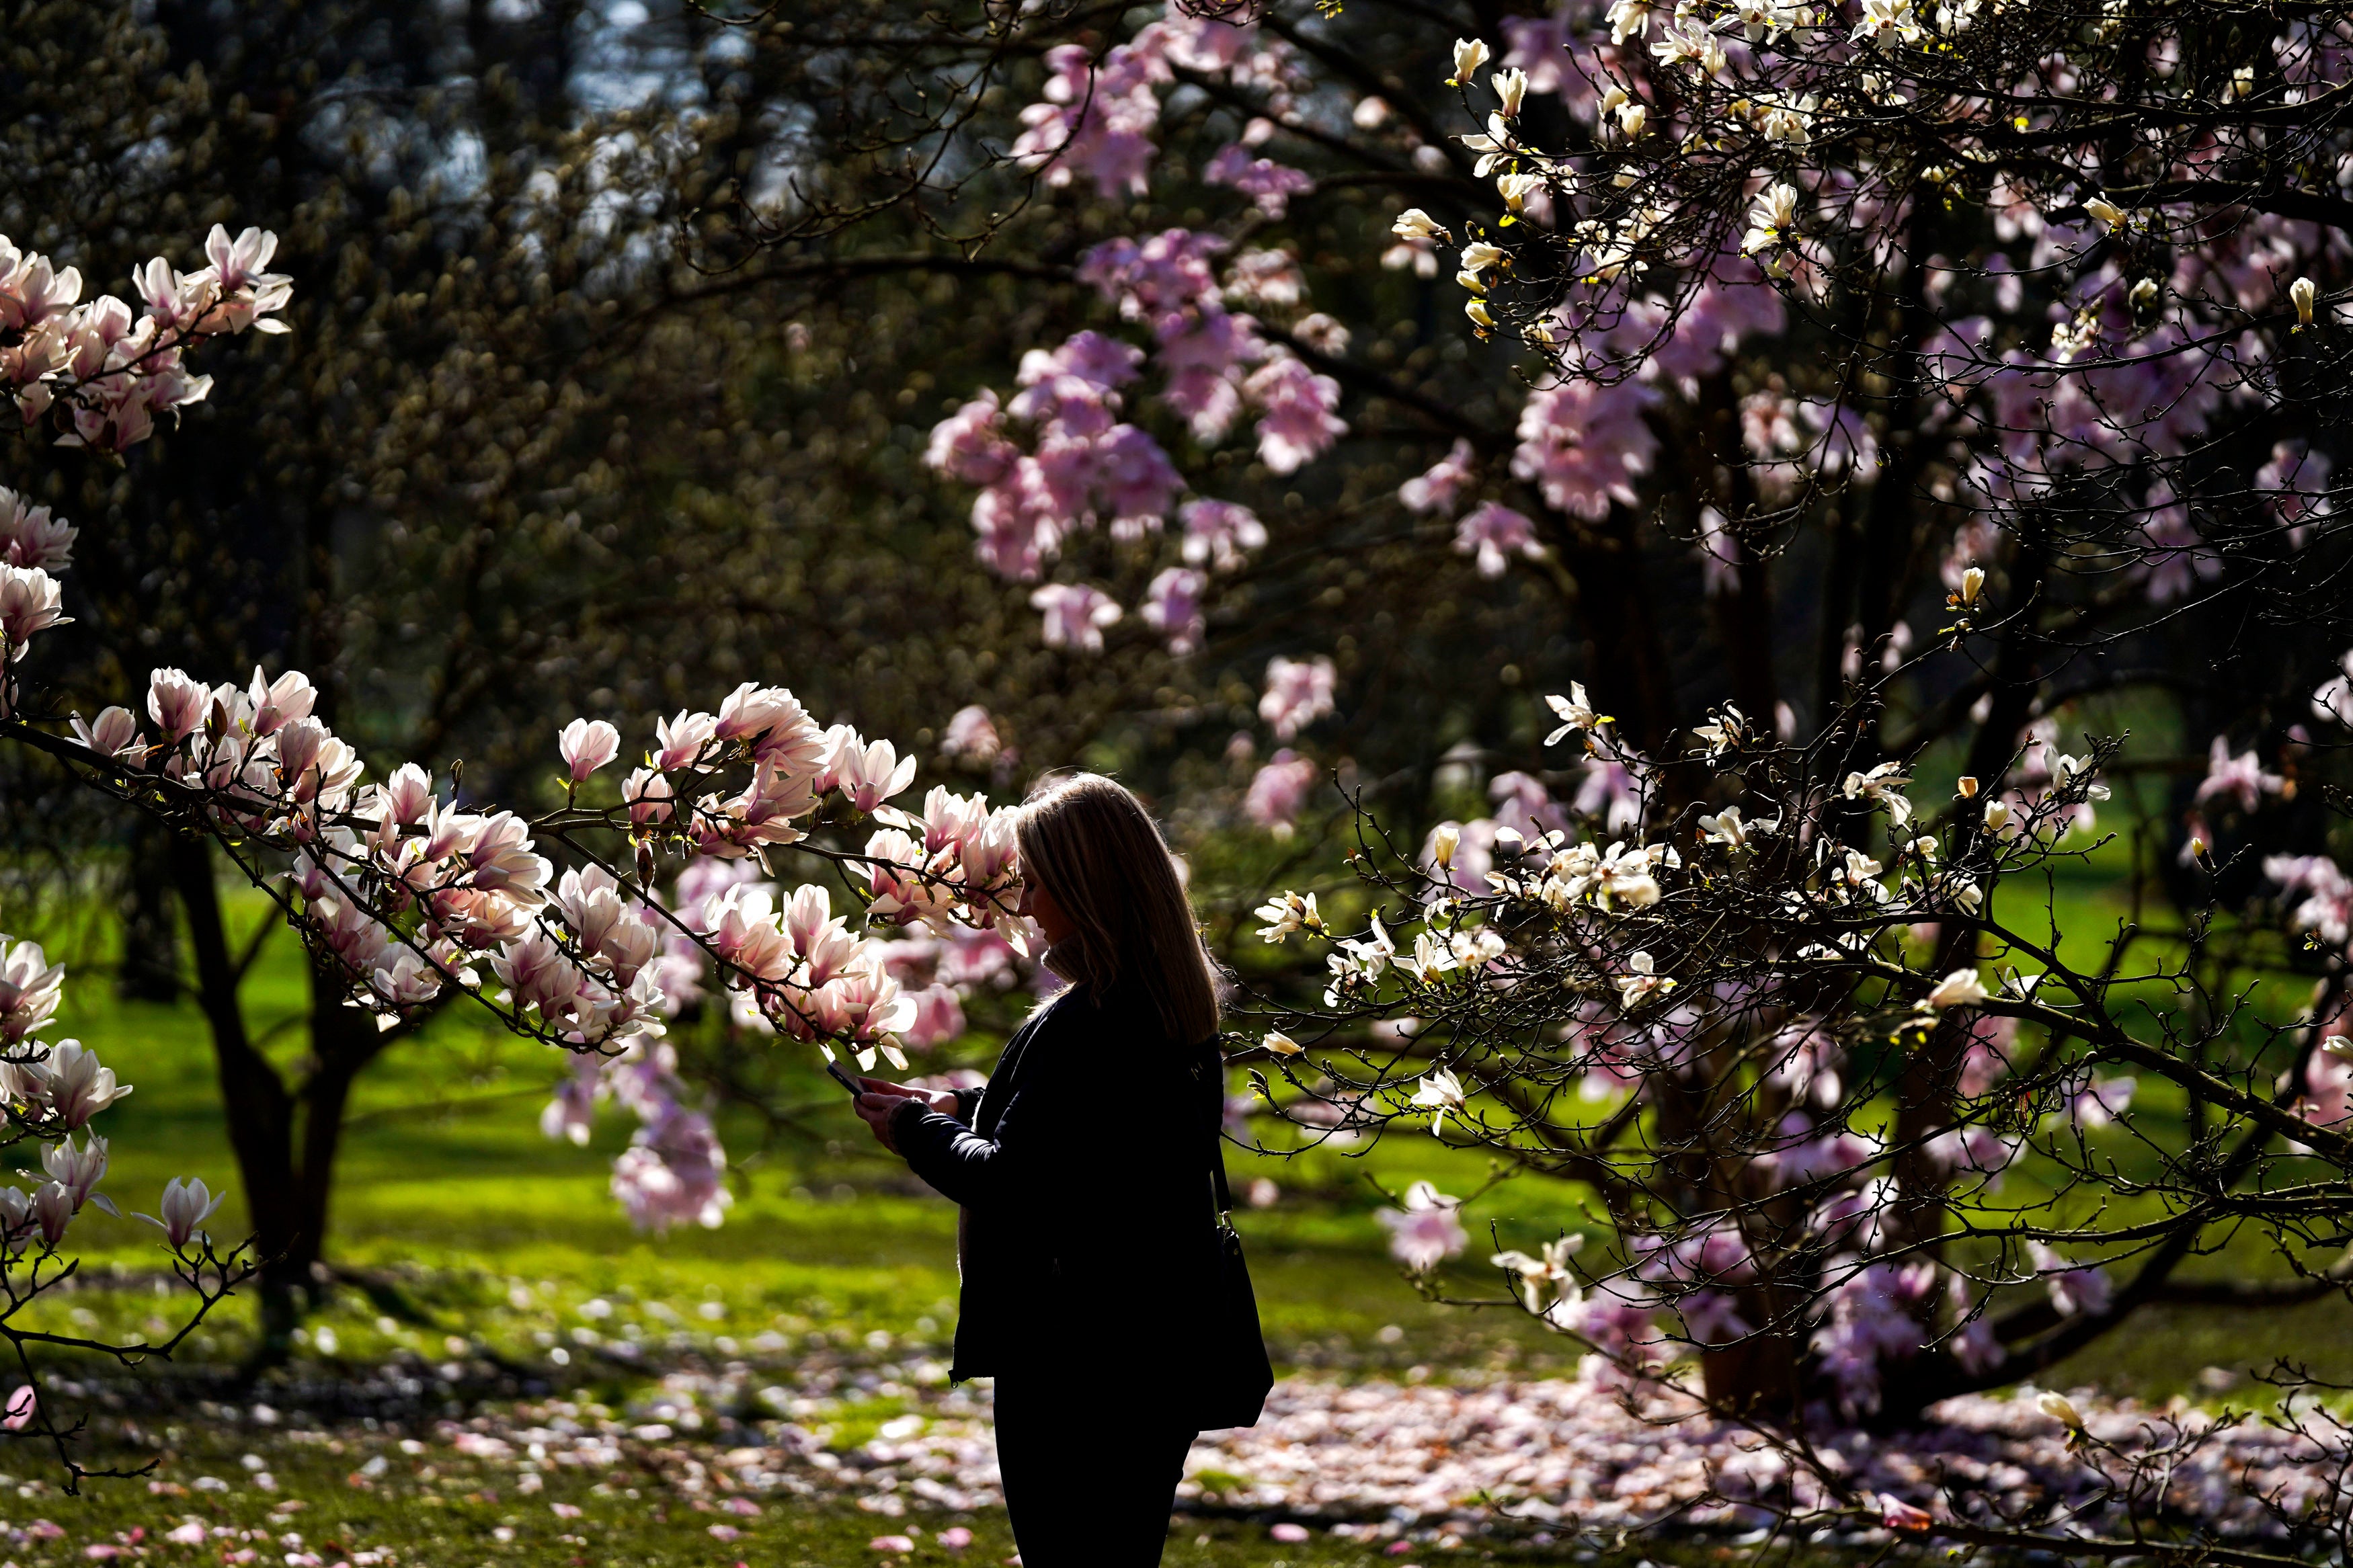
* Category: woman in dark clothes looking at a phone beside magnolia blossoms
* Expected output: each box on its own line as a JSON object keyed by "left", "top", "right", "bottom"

{"left": 856, "top": 774, "right": 1231, "bottom": 1568}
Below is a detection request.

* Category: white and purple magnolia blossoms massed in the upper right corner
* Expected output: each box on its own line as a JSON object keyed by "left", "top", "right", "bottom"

{"left": 1396, "top": 0, "right": 2342, "bottom": 606}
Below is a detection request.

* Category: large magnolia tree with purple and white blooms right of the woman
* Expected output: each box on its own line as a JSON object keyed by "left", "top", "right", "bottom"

{"left": 711, "top": 0, "right": 2353, "bottom": 1561}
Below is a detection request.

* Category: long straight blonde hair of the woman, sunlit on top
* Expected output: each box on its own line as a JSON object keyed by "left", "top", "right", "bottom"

{"left": 1014, "top": 774, "right": 1217, "bottom": 1046}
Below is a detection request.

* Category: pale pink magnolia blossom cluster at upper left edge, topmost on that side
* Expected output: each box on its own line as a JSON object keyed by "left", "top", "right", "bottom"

{"left": 0, "top": 226, "right": 292, "bottom": 452}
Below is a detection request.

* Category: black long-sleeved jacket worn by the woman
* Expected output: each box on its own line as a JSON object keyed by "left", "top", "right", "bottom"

{"left": 889, "top": 985, "right": 1224, "bottom": 1378}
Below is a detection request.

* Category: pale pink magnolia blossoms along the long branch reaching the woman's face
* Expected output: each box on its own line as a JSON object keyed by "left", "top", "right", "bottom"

{"left": 62, "top": 670, "right": 1014, "bottom": 1225}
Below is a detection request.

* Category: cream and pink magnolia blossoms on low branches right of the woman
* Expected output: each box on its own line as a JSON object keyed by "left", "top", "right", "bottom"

{"left": 1259, "top": 686, "right": 2165, "bottom": 1415}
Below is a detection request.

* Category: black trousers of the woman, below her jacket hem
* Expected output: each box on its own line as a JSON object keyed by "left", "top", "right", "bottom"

{"left": 998, "top": 1370, "right": 1195, "bottom": 1568}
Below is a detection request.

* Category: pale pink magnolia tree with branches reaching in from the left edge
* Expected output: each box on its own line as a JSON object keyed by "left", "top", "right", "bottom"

{"left": 0, "top": 228, "right": 1026, "bottom": 1477}
